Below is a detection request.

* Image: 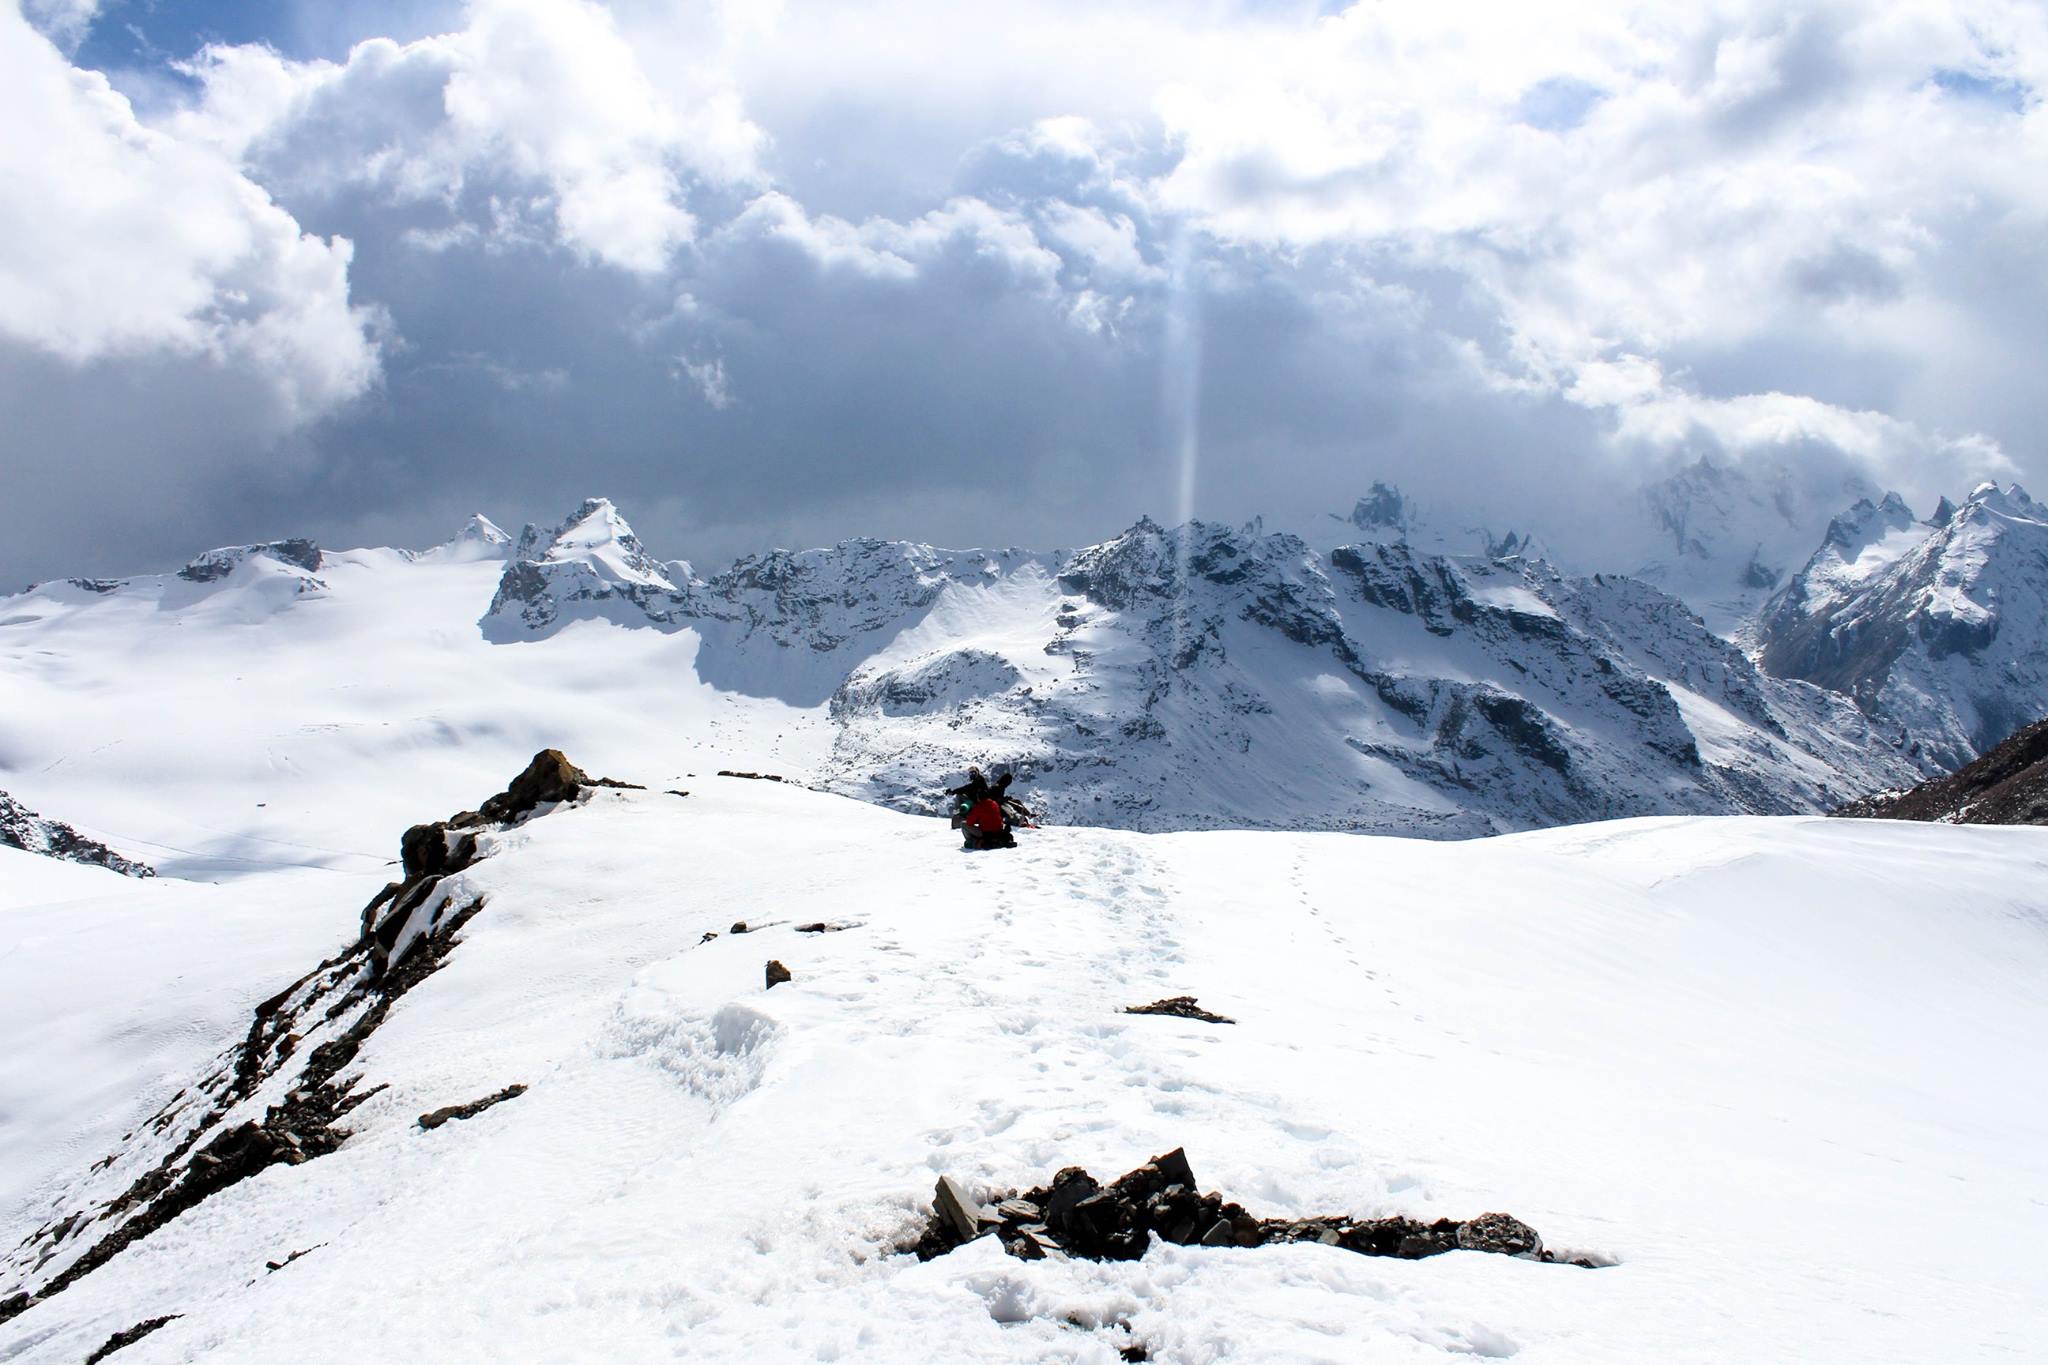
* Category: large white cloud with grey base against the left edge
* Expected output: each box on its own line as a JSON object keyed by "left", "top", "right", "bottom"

{"left": 0, "top": 6, "right": 383, "bottom": 577}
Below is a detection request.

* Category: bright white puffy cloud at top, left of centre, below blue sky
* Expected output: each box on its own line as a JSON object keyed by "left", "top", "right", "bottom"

{"left": 178, "top": 0, "right": 766, "bottom": 274}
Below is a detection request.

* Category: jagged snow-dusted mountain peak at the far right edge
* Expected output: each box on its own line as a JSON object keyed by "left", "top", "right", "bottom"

{"left": 1757, "top": 483, "right": 2048, "bottom": 772}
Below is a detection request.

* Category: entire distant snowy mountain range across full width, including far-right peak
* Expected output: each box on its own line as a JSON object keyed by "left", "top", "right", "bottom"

{"left": 0, "top": 463, "right": 2048, "bottom": 855}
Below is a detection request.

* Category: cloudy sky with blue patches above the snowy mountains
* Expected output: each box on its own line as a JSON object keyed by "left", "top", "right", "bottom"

{"left": 0, "top": 0, "right": 2048, "bottom": 587}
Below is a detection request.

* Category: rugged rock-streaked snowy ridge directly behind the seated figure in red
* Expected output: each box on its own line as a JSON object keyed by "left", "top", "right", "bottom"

{"left": 483, "top": 499, "right": 1919, "bottom": 837}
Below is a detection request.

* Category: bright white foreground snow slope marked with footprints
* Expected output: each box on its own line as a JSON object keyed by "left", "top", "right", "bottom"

{"left": 0, "top": 767, "right": 2048, "bottom": 1365}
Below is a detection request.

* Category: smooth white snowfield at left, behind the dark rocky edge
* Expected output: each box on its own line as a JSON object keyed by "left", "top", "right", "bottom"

{"left": 0, "top": 518, "right": 829, "bottom": 878}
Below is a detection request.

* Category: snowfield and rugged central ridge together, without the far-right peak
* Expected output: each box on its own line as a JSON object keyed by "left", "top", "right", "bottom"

{"left": 0, "top": 489, "right": 2007, "bottom": 876}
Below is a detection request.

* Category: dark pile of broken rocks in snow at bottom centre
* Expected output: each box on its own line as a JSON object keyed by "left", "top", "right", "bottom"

{"left": 909, "top": 1148, "right": 1597, "bottom": 1269}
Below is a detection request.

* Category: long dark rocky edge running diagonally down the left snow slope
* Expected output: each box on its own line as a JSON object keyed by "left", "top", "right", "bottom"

{"left": 0, "top": 749, "right": 631, "bottom": 1324}
